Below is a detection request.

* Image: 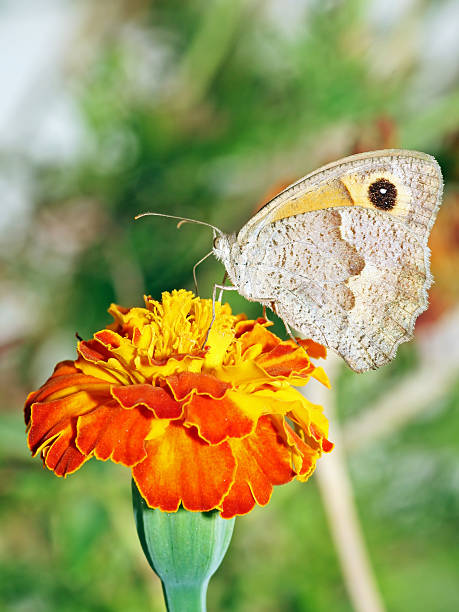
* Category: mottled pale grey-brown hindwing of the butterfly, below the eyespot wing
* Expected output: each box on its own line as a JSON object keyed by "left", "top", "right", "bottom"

{"left": 252, "top": 207, "right": 431, "bottom": 371}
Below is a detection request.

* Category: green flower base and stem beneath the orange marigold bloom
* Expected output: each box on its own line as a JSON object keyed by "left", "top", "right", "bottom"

{"left": 132, "top": 481, "right": 234, "bottom": 612}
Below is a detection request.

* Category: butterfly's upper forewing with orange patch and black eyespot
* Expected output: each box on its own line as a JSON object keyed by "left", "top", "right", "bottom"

{"left": 238, "top": 149, "right": 443, "bottom": 244}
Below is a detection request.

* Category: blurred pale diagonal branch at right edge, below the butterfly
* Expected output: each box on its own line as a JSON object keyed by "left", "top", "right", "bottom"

{"left": 343, "top": 308, "right": 459, "bottom": 451}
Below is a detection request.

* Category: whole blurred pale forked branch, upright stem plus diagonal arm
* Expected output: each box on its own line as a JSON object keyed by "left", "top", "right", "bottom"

{"left": 302, "top": 307, "right": 459, "bottom": 612}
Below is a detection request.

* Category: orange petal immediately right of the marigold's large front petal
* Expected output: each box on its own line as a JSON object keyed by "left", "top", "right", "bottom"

{"left": 221, "top": 417, "right": 295, "bottom": 518}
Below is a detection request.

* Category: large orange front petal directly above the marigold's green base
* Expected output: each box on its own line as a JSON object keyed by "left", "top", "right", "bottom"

{"left": 132, "top": 422, "right": 236, "bottom": 512}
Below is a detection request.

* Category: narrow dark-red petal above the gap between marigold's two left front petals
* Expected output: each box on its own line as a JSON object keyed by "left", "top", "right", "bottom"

{"left": 112, "top": 385, "right": 183, "bottom": 419}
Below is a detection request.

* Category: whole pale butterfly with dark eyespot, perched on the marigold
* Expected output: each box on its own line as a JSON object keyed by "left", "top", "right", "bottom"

{"left": 138, "top": 149, "right": 443, "bottom": 372}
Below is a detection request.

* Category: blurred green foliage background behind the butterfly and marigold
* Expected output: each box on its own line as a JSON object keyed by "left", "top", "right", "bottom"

{"left": 0, "top": 0, "right": 459, "bottom": 612}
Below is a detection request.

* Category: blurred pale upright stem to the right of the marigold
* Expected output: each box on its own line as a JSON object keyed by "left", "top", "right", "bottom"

{"left": 300, "top": 354, "right": 384, "bottom": 612}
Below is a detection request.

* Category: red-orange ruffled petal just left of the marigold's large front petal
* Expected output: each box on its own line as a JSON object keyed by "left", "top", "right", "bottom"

{"left": 76, "top": 400, "right": 154, "bottom": 467}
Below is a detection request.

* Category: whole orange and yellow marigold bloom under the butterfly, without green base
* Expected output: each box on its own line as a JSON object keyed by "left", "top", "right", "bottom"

{"left": 25, "top": 290, "right": 332, "bottom": 518}
